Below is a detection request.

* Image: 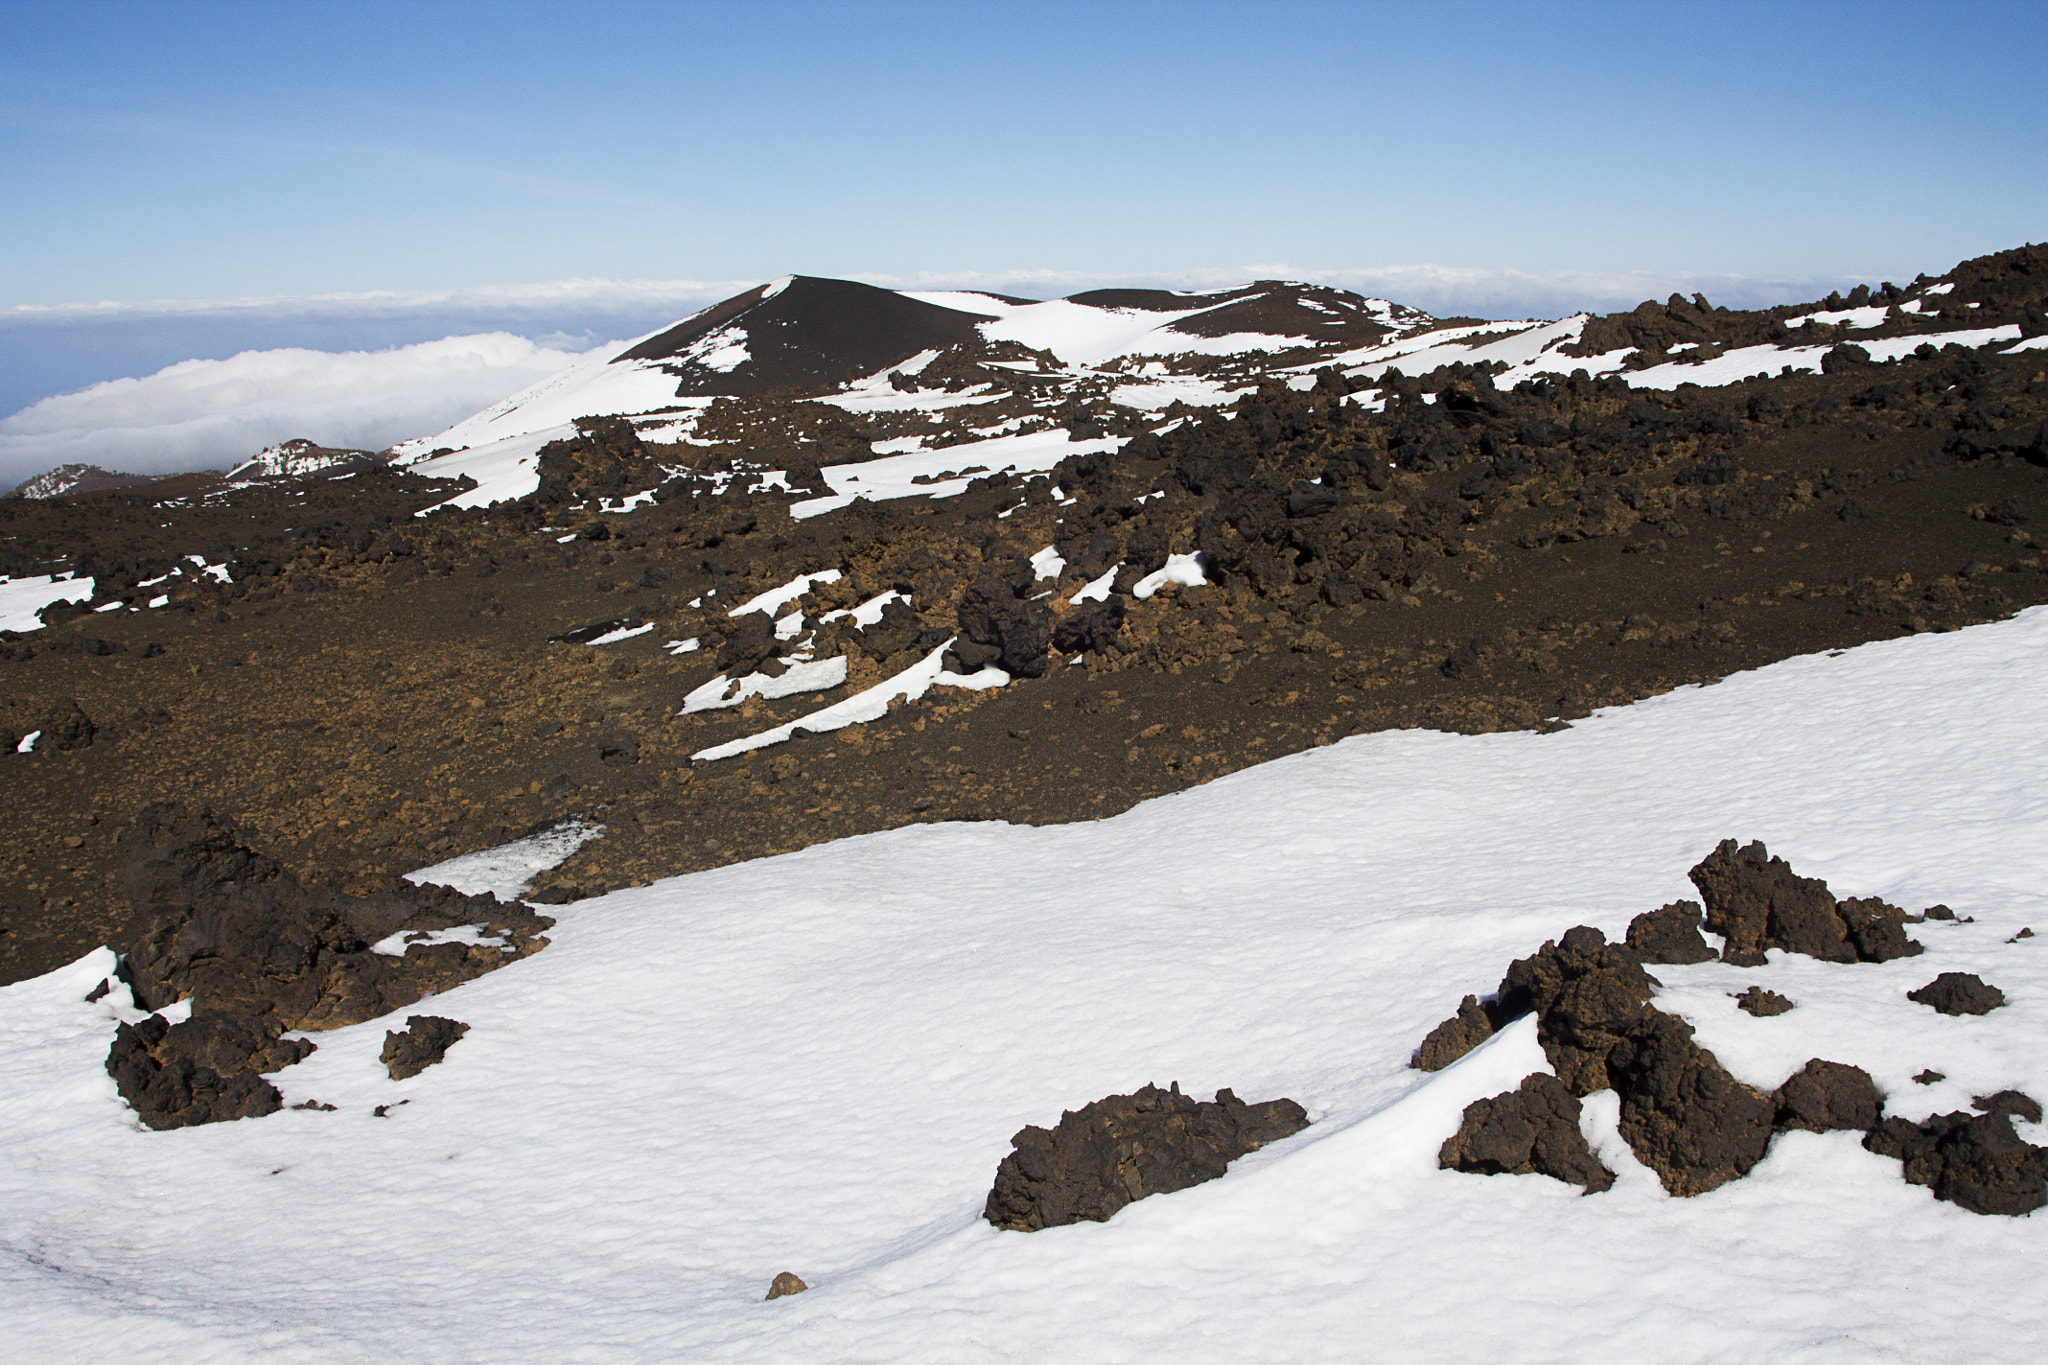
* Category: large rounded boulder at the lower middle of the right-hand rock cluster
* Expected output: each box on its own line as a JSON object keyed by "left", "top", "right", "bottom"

{"left": 1608, "top": 1011, "right": 1778, "bottom": 1195}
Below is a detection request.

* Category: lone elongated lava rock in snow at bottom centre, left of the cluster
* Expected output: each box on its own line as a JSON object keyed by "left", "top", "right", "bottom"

{"left": 983, "top": 1085, "right": 1309, "bottom": 1232}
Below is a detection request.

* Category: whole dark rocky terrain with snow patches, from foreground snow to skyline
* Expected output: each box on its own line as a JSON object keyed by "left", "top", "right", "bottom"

{"left": 0, "top": 248, "right": 2048, "bottom": 998}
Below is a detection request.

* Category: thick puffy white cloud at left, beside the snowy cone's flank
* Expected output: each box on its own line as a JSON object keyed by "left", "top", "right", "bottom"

{"left": 0, "top": 332, "right": 598, "bottom": 485}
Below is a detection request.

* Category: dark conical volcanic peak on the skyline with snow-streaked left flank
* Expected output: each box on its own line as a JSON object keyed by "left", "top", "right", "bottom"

{"left": 618, "top": 274, "right": 995, "bottom": 397}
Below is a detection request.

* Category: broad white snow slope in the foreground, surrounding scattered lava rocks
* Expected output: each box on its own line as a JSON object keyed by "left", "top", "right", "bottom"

{"left": 0, "top": 608, "right": 2048, "bottom": 1365}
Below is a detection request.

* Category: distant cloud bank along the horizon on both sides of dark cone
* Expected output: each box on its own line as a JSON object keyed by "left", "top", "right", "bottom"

{"left": 0, "top": 262, "right": 1853, "bottom": 487}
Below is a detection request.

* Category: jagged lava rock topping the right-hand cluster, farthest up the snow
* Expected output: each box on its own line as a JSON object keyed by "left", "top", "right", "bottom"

{"left": 1690, "top": 839, "right": 1921, "bottom": 966}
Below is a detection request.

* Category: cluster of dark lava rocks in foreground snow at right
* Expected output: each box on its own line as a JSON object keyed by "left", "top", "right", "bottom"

{"left": 1411, "top": 839, "right": 2048, "bottom": 1214}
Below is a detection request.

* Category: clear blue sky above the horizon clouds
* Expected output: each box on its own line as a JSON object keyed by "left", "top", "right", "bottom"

{"left": 0, "top": 0, "right": 2048, "bottom": 307}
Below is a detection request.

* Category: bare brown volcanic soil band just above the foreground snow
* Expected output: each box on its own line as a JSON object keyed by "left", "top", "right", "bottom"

{"left": 0, "top": 341, "right": 2048, "bottom": 980}
